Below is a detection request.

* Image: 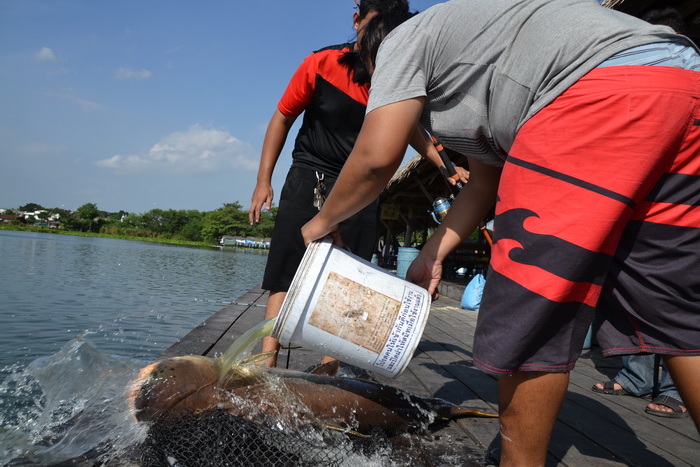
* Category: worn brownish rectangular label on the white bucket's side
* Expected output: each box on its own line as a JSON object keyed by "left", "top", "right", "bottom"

{"left": 308, "top": 272, "right": 401, "bottom": 354}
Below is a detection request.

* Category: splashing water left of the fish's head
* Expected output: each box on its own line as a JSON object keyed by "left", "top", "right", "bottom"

{"left": 0, "top": 335, "right": 146, "bottom": 465}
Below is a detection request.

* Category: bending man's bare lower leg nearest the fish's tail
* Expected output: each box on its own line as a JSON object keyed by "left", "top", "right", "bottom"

{"left": 498, "top": 371, "right": 569, "bottom": 467}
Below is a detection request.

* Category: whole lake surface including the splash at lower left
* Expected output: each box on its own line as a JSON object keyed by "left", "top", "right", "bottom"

{"left": 0, "top": 231, "right": 267, "bottom": 465}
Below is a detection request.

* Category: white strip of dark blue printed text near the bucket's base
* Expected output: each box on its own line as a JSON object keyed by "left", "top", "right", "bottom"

{"left": 374, "top": 288, "right": 424, "bottom": 372}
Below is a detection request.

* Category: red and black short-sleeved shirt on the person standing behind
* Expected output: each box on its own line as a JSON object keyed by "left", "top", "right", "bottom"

{"left": 277, "top": 43, "right": 369, "bottom": 177}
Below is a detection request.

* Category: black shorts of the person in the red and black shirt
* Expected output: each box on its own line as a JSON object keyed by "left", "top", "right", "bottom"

{"left": 262, "top": 167, "right": 379, "bottom": 292}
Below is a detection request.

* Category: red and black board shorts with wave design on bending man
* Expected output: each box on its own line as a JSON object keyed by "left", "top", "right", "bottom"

{"left": 474, "top": 66, "right": 700, "bottom": 375}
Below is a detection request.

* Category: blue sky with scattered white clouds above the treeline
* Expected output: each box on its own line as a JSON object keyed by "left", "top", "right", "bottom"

{"left": 0, "top": 0, "right": 440, "bottom": 214}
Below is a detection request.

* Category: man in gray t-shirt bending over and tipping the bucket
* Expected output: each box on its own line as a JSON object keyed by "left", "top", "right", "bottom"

{"left": 302, "top": 0, "right": 700, "bottom": 465}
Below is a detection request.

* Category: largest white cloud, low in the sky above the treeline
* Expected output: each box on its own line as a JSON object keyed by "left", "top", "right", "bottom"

{"left": 96, "top": 125, "right": 258, "bottom": 174}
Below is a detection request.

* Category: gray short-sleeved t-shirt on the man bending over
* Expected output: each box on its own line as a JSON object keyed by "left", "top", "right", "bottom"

{"left": 367, "top": 0, "right": 692, "bottom": 166}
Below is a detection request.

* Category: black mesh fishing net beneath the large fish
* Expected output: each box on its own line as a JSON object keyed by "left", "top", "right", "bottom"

{"left": 140, "top": 409, "right": 391, "bottom": 467}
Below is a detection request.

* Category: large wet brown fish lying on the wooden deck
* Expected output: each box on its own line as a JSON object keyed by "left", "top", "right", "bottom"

{"left": 129, "top": 354, "right": 498, "bottom": 436}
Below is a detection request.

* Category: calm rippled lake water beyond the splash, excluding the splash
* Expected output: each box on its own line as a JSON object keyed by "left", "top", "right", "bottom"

{"left": 0, "top": 230, "right": 267, "bottom": 368}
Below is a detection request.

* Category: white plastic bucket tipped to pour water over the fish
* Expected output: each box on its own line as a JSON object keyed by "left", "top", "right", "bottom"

{"left": 272, "top": 238, "right": 430, "bottom": 377}
